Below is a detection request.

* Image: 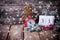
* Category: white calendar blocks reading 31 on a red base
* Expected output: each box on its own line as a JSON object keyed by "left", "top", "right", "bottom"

{"left": 39, "top": 15, "right": 55, "bottom": 26}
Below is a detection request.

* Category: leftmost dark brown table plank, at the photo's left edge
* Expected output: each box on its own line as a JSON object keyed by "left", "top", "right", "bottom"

{"left": 0, "top": 25, "right": 9, "bottom": 40}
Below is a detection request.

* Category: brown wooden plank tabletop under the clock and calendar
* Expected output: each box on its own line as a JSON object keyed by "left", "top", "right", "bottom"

{"left": 0, "top": 25, "right": 57, "bottom": 40}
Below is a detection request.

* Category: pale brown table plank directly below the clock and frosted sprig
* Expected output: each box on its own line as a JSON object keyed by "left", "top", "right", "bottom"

{"left": 24, "top": 29, "right": 40, "bottom": 40}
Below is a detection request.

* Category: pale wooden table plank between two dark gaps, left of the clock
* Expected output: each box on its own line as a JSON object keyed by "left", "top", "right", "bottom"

{"left": 9, "top": 25, "right": 23, "bottom": 40}
